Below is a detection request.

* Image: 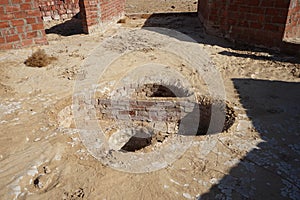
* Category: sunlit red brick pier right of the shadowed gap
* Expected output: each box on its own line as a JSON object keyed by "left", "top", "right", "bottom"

{"left": 80, "top": 0, "right": 125, "bottom": 33}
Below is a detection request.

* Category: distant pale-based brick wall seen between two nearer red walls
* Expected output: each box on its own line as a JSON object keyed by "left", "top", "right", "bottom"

{"left": 38, "top": 0, "right": 80, "bottom": 21}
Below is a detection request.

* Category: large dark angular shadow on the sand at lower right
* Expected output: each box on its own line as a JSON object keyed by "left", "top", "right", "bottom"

{"left": 200, "top": 79, "right": 300, "bottom": 199}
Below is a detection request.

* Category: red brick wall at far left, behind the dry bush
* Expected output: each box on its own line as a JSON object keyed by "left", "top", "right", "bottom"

{"left": 0, "top": 0, "right": 47, "bottom": 49}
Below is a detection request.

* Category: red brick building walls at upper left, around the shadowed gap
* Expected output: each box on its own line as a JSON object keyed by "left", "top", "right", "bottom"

{"left": 0, "top": 0, "right": 125, "bottom": 49}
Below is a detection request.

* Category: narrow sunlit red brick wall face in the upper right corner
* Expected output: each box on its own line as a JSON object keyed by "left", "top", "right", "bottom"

{"left": 284, "top": 0, "right": 300, "bottom": 40}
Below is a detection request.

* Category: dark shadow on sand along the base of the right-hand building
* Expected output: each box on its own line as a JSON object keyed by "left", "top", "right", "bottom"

{"left": 143, "top": 12, "right": 300, "bottom": 63}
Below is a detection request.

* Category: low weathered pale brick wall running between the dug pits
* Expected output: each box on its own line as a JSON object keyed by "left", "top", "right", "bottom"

{"left": 96, "top": 99, "right": 195, "bottom": 122}
